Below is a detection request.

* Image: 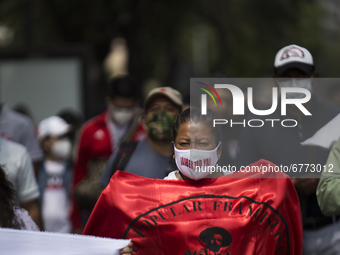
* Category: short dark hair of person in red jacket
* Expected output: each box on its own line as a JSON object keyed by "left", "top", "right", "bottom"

{"left": 108, "top": 75, "right": 141, "bottom": 100}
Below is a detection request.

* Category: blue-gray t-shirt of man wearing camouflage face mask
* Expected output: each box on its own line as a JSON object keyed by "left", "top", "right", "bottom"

{"left": 100, "top": 138, "right": 171, "bottom": 186}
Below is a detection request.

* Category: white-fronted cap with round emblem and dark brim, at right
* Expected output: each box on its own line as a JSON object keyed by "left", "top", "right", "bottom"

{"left": 274, "top": 44, "right": 314, "bottom": 75}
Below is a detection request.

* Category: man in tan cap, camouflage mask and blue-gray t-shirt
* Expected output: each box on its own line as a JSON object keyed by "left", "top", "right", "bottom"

{"left": 101, "top": 87, "right": 183, "bottom": 186}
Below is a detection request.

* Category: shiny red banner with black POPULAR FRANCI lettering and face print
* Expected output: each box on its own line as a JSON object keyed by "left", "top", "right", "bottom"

{"left": 84, "top": 160, "right": 302, "bottom": 255}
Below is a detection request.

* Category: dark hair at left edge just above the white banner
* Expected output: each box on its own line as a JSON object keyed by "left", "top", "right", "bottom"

{"left": 0, "top": 165, "right": 18, "bottom": 228}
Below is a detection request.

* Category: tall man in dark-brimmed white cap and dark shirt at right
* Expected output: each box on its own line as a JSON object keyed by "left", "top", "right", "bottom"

{"left": 237, "top": 45, "right": 340, "bottom": 254}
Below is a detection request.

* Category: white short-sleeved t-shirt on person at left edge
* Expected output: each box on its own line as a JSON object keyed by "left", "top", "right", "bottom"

{"left": 0, "top": 137, "right": 40, "bottom": 205}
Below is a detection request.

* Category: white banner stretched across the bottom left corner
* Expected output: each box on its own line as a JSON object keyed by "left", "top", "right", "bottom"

{"left": 0, "top": 228, "right": 130, "bottom": 255}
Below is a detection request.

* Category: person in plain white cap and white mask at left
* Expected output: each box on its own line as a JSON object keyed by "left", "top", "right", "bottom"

{"left": 38, "top": 116, "right": 72, "bottom": 233}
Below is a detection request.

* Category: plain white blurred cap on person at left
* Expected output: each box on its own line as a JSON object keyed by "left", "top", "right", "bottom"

{"left": 38, "top": 116, "right": 71, "bottom": 141}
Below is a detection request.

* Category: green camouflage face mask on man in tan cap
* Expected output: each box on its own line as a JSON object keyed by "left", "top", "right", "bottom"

{"left": 145, "top": 111, "right": 176, "bottom": 141}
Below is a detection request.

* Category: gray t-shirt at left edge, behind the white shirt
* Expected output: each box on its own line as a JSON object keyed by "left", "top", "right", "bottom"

{"left": 0, "top": 104, "right": 43, "bottom": 161}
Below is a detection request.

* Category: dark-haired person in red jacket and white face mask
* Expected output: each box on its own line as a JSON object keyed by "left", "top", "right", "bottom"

{"left": 71, "top": 76, "right": 145, "bottom": 233}
